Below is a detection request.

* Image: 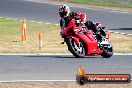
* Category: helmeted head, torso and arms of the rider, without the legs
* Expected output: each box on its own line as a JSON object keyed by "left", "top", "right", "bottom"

{"left": 59, "top": 5, "right": 86, "bottom": 28}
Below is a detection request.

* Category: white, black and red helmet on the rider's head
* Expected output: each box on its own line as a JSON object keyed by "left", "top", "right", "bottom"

{"left": 59, "top": 5, "right": 70, "bottom": 18}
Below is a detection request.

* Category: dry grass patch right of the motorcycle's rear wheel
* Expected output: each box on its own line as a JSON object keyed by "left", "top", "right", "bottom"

{"left": 111, "top": 33, "right": 132, "bottom": 53}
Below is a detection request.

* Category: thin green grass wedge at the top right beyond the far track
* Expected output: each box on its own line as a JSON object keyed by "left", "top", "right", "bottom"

{"left": 54, "top": 0, "right": 132, "bottom": 8}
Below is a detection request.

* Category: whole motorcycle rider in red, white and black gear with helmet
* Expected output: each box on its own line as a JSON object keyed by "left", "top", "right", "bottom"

{"left": 59, "top": 5, "right": 101, "bottom": 39}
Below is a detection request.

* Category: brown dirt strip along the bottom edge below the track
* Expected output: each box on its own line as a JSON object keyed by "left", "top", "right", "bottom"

{"left": 0, "top": 82, "right": 132, "bottom": 88}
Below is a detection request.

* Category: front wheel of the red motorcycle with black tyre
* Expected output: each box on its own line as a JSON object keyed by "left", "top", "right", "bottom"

{"left": 67, "top": 38, "right": 86, "bottom": 58}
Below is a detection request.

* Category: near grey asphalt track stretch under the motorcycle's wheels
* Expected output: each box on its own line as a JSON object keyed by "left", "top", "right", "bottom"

{"left": 0, "top": 55, "right": 132, "bottom": 81}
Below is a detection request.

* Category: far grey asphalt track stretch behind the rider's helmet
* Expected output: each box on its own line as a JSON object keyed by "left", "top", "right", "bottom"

{"left": 0, "top": 0, "right": 132, "bottom": 34}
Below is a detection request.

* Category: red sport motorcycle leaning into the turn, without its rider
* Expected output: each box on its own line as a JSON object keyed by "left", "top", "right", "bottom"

{"left": 60, "top": 18, "right": 113, "bottom": 58}
